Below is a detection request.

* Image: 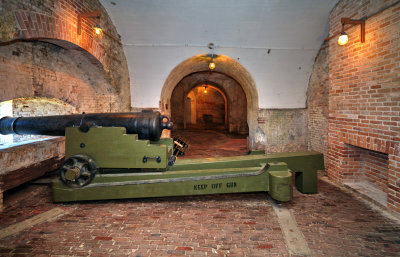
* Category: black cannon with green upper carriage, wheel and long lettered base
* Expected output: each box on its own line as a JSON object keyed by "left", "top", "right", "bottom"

{"left": 0, "top": 111, "right": 322, "bottom": 202}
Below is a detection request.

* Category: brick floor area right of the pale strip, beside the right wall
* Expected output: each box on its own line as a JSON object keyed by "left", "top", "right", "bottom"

{"left": 285, "top": 176, "right": 400, "bottom": 256}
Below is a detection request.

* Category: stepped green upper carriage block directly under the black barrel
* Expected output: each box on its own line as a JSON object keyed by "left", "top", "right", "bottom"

{"left": 65, "top": 127, "right": 172, "bottom": 170}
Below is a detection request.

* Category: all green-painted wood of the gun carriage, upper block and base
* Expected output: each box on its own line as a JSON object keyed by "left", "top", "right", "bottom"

{"left": 53, "top": 127, "right": 323, "bottom": 202}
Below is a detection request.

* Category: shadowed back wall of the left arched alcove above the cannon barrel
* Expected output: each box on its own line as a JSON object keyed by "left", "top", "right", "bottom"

{"left": 0, "top": 40, "right": 125, "bottom": 112}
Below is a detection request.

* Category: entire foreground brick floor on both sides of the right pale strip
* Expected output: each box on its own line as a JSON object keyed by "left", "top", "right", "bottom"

{"left": 0, "top": 130, "right": 400, "bottom": 256}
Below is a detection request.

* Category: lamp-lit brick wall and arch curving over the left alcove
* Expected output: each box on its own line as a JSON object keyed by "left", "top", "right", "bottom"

{"left": 0, "top": 4, "right": 131, "bottom": 111}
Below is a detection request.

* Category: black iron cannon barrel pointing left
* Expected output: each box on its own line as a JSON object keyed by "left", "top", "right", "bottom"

{"left": 0, "top": 111, "right": 172, "bottom": 141}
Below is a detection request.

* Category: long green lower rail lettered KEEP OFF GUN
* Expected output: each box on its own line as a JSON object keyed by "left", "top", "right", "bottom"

{"left": 53, "top": 163, "right": 291, "bottom": 202}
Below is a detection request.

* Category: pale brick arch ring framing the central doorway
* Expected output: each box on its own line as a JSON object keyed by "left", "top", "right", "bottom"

{"left": 160, "top": 54, "right": 259, "bottom": 149}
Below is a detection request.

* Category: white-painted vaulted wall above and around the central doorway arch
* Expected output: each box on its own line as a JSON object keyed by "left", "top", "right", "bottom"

{"left": 101, "top": 0, "right": 337, "bottom": 108}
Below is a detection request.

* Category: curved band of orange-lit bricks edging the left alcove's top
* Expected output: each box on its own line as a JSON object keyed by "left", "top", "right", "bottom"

{"left": 15, "top": 10, "right": 106, "bottom": 64}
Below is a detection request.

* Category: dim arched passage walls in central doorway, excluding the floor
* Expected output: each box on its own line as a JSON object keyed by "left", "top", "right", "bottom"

{"left": 170, "top": 71, "right": 249, "bottom": 135}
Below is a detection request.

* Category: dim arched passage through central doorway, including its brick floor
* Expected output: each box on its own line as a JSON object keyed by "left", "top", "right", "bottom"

{"left": 171, "top": 72, "right": 249, "bottom": 157}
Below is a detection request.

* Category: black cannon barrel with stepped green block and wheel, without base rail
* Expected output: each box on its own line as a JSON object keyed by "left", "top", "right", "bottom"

{"left": 0, "top": 111, "right": 176, "bottom": 188}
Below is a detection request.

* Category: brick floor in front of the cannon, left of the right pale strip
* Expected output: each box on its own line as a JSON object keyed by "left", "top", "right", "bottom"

{"left": 0, "top": 185, "right": 288, "bottom": 256}
